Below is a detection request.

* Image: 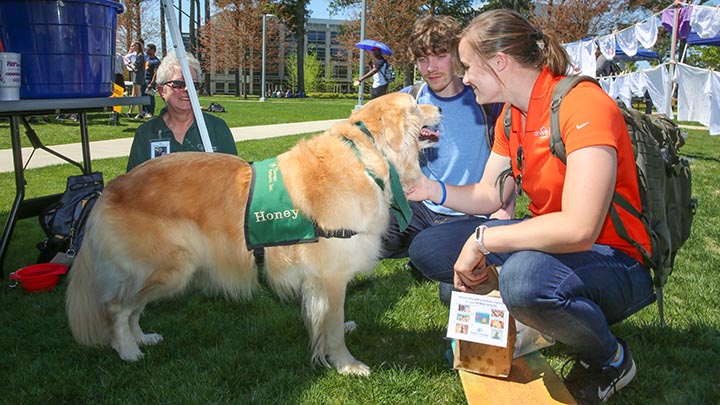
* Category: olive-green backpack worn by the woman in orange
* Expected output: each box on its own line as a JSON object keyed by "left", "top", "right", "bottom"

{"left": 503, "top": 76, "right": 698, "bottom": 326}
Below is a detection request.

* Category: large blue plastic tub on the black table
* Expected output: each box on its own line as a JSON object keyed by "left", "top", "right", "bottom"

{"left": 0, "top": 0, "right": 123, "bottom": 98}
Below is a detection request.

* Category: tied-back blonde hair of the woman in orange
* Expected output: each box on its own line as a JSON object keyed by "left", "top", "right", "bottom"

{"left": 460, "top": 9, "right": 570, "bottom": 76}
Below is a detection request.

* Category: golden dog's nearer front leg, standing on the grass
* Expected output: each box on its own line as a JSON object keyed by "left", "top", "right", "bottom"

{"left": 303, "top": 273, "right": 370, "bottom": 376}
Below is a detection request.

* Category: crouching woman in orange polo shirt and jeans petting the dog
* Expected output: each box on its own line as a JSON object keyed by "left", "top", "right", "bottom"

{"left": 408, "top": 10, "right": 654, "bottom": 403}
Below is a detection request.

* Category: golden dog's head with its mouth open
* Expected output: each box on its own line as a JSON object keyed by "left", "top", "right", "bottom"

{"left": 350, "top": 93, "right": 440, "bottom": 188}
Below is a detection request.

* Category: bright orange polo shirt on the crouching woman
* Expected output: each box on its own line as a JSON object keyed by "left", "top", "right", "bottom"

{"left": 493, "top": 68, "right": 650, "bottom": 262}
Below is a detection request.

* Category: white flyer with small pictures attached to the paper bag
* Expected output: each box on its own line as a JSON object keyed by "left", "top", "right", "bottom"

{"left": 447, "top": 291, "right": 510, "bottom": 347}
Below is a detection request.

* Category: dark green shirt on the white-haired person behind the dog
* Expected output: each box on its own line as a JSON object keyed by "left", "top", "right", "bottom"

{"left": 127, "top": 108, "right": 237, "bottom": 171}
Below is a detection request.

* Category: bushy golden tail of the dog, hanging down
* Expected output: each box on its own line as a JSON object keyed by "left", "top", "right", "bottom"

{"left": 65, "top": 239, "right": 110, "bottom": 346}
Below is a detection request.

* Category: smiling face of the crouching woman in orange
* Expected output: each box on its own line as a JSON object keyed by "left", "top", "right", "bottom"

{"left": 458, "top": 39, "right": 505, "bottom": 104}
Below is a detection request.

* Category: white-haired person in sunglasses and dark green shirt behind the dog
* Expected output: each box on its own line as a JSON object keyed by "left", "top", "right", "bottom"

{"left": 127, "top": 53, "right": 237, "bottom": 171}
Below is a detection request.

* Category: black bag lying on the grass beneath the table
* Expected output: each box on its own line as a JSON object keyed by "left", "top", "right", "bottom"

{"left": 37, "top": 172, "right": 104, "bottom": 264}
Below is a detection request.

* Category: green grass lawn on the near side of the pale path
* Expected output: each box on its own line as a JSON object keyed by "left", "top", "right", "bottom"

{"left": 0, "top": 113, "right": 720, "bottom": 404}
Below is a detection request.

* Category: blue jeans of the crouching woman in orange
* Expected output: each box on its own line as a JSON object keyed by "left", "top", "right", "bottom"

{"left": 410, "top": 220, "right": 655, "bottom": 364}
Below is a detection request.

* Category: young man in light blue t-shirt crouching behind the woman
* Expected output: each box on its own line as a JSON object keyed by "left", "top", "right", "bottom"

{"left": 383, "top": 16, "right": 515, "bottom": 304}
